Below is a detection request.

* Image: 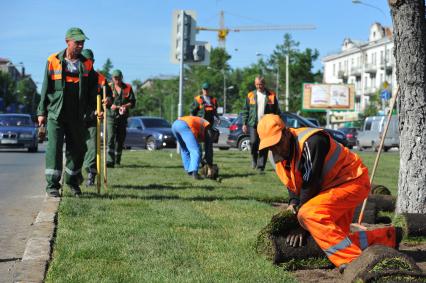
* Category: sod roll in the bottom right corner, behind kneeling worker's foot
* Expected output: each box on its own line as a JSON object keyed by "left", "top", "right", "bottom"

{"left": 344, "top": 245, "right": 426, "bottom": 282}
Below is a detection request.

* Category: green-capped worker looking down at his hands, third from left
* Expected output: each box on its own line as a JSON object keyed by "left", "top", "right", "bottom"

{"left": 107, "top": 70, "right": 136, "bottom": 168}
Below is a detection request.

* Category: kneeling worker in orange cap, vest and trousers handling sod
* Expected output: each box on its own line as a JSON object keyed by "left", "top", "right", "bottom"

{"left": 257, "top": 114, "right": 397, "bottom": 272}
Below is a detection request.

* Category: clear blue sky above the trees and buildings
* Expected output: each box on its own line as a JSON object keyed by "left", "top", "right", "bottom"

{"left": 0, "top": 0, "right": 391, "bottom": 90}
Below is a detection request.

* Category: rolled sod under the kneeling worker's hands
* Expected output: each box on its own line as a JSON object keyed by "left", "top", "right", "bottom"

{"left": 256, "top": 210, "right": 331, "bottom": 270}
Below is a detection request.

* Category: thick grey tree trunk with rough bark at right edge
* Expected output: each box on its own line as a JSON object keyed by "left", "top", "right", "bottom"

{"left": 389, "top": 0, "right": 426, "bottom": 213}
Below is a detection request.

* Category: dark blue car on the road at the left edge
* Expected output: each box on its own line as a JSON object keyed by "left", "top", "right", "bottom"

{"left": 0, "top": 114, "right": 38, "bottom": 152}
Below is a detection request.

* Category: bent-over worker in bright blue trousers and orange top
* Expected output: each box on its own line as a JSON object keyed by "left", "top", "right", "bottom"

{"left": 172, "top": 116, "right": 213, "bottom": 180}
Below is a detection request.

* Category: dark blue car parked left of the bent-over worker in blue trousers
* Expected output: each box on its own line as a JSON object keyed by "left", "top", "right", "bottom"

{"left": 124, "top": 116, "right": 176, "bottom": 150}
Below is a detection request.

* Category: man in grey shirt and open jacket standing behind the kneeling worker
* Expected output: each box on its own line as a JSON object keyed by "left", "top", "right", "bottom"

{"left": 242, "top": 76, "right": 281, "bottom": 173}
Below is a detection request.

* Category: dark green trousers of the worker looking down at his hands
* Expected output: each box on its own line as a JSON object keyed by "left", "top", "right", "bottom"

{"left": 107, "top": 117, "right": 127, "bottom": 165}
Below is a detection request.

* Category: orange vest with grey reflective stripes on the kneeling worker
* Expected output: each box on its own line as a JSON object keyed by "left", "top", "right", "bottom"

{"left": 276, "top": 128, "right": 367, "bottom": 195}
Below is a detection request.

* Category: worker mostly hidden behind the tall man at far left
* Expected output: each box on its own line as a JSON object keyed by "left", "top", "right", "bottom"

{"left": 81, "top": 49, "right": 112, "bottom": 186}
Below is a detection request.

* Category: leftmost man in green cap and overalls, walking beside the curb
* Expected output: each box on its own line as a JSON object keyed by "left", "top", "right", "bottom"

{"left": 37, "top": 28, "right": 98, "bottom": 197}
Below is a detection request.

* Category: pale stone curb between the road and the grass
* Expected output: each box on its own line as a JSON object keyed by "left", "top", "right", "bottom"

{"left": 13, "top": 197, "right": 60, "bottom": 283}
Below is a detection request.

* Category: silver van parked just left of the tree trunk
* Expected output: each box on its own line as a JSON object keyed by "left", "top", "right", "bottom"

{"left": 357, "top": 115, "right": 399, "bottom": 151}
